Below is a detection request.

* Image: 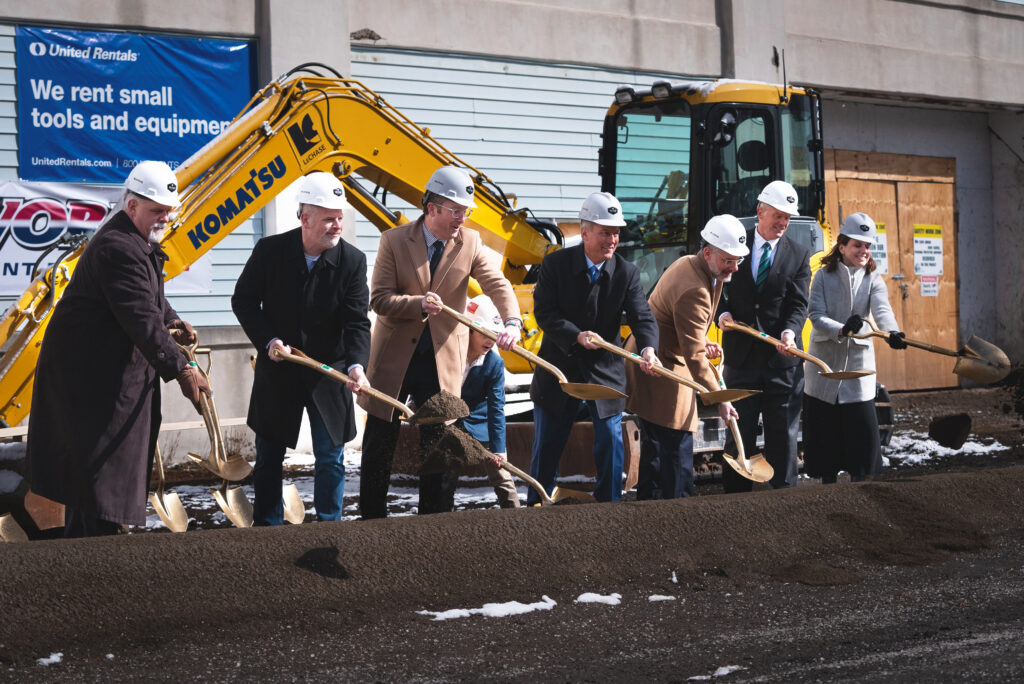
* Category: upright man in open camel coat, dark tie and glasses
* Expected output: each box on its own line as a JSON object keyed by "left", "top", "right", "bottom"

{"left": 359, "top": 166, "right": 522, "bottom": 518}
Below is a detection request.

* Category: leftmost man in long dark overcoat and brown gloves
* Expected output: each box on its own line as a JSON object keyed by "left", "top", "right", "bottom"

{"left": 28, "top": 162, "right": 210, "bottom": 537}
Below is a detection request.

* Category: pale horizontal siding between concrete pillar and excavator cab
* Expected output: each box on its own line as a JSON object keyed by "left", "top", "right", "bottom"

{"left": 351, "top": 46, "right": 679, "bottom": 260}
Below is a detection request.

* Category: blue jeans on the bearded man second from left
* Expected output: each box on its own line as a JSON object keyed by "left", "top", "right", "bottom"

{"left": 253, "top": 400, "right": 345, "bottom": 525}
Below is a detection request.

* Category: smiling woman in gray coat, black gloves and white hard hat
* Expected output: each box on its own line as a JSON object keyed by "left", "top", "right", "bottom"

{"left": 804, "top": 213, "right": 906, "bottom": 484}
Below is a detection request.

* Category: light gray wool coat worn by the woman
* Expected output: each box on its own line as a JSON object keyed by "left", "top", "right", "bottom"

{"left": 804, "top": 263, "right": 899, "bottom": 403}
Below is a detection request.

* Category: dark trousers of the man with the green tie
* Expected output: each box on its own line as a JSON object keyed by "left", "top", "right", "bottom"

{"left": 722, "top": 365, "right": 804, "bottom": 494}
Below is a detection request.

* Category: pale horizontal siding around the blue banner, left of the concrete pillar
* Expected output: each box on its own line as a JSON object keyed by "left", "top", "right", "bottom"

{"left": 0, "top": 25, "right": 263, "bottom": 326}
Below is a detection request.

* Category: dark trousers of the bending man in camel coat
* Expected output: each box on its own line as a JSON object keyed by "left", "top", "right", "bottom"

{"left": 637, "top": 418, "right": 693, "bottom": 500}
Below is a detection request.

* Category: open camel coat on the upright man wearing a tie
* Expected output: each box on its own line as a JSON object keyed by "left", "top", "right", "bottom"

{"left": 358, "top": 216, "right": 520, "bottom": 421}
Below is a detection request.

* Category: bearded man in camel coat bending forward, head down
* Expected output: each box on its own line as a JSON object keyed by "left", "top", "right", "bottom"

{"left": 626, "top": 214, "right": 750, "bottom": 500}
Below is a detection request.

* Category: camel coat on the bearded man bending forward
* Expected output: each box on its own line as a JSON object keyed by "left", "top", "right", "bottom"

{"left": 626, "top": 253, "right": 723, "bottom": 432}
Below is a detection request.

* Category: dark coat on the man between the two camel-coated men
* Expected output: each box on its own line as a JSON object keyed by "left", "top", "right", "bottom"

{"left": 529, "top": 244, "right": 657, "bottom": 418}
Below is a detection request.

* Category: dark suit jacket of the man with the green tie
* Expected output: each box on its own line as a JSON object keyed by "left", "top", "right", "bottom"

{"left": 715, "top": 230, "right": 811, "bottom": 369}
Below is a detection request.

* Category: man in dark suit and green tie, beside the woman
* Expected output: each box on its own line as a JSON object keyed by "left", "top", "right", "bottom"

{"left": 718, "top": 180, "right": 811, "bottom": 493}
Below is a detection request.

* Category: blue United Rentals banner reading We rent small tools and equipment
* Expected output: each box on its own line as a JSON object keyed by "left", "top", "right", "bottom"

{"left": 16, "top": 27, "right": 253, "bottom": 183}
